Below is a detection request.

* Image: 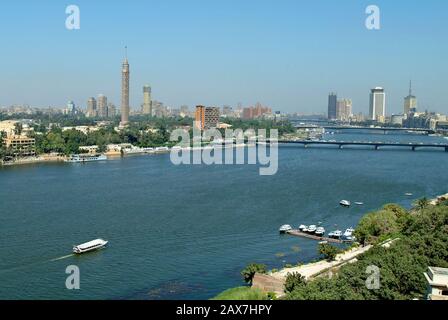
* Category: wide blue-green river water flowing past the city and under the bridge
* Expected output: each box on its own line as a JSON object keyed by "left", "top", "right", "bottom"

{"left": 0, "top": 132, "right": 448, "bottom": 299}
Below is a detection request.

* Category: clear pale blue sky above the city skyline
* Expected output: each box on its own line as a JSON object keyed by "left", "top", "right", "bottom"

{"left": 0, "top": 0, "right": 448, "bottom": 113}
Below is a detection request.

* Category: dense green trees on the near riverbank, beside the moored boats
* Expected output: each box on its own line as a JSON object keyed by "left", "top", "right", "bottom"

{"left": 286, "top": 204, "right": 448, "bottom": 300}
